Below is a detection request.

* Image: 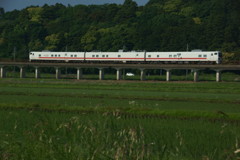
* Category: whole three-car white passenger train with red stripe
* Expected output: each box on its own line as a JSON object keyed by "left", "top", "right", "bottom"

{"left": 29, "top": 50, "right": 222, "bottom": 64}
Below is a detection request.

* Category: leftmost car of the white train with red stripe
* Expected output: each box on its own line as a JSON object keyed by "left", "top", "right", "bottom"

{"left": 29, "top": 51, "right": 85, "bottom": 62}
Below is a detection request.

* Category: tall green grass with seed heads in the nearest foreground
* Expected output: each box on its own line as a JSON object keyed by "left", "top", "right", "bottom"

{"left": 0, "top": 110, "right": 240, "bottom": 160}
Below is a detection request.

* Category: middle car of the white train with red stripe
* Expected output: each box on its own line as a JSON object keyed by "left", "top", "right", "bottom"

{"left": 85, "top": 52, "right": 145, "bottom": 63}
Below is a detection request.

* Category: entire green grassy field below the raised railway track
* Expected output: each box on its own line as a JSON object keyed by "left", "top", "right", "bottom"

{"left": 0, "top": 78, "right": 240, "bottom": 160}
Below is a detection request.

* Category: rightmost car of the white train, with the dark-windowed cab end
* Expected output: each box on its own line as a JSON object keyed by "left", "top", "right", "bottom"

{"left": 146, "top": 51, "right": 221, "bottom": 64}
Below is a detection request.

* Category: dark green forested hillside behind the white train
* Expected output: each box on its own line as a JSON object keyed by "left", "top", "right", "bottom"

{"left": 0, "top": 0, "right": 240, "bottom": 59}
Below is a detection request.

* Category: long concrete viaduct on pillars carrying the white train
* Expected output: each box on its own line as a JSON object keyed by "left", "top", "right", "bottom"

{"left": 0, "top": 62, "right": 240, "bottom": 82}
